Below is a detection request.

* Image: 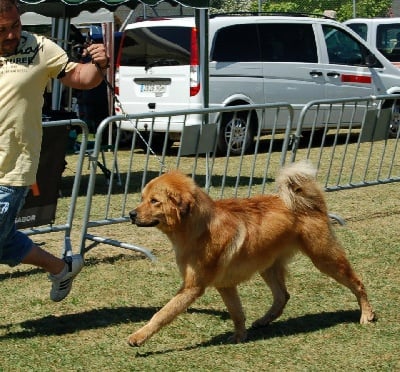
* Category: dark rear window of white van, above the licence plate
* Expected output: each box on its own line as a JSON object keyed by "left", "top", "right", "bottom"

{"left": 120, "top": 26, "right": 191, "bottom": 68}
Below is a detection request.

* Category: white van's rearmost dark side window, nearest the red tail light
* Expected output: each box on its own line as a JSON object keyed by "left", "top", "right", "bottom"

{"left": 211, "top": 24, "right": 261, "bottom": 62}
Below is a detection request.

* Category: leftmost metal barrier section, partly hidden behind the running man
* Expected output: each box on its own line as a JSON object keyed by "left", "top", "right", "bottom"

{"left": 21, "top": 119, "right": 89, "bottom": 255}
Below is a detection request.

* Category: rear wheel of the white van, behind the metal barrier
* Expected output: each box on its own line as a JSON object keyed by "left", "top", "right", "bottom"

{"left": 218, "top": 111, "right": 254, "bottom": 155}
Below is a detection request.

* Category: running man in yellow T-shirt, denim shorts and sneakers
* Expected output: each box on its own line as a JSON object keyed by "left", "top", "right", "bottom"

{"left": 0, "top": 0, "right": 109, "bottom": 301}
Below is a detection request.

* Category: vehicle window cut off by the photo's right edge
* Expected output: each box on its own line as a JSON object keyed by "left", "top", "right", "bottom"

{"left": 376, "top": 23, "right": 400, "bottom": 62}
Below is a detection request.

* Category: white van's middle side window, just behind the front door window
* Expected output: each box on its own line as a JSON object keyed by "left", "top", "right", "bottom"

{"left": 259, "top": 23, "right": 318, "bottom": 63}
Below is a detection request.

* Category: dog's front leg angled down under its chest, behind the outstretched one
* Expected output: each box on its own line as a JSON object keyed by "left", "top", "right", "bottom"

{"left": 217, "top": 287, "right": 247, "bottom": 343}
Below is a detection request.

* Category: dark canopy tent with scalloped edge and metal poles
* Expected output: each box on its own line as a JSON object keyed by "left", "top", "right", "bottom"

{"left": 20, "top": 0, "right": 209, "bottom": 109}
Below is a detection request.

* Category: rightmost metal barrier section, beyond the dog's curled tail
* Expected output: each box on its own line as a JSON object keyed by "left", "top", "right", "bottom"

{"left": 291, "top": 95, "right": 400, "bottom": 191}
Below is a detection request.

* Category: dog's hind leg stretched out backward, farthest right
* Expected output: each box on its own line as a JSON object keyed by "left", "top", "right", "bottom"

{"left": 303, "top": 234, "right": 375, "bottom": 324}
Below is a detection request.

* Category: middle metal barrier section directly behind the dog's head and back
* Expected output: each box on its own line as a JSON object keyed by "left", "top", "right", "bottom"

{"left": 81, "top": 103, "right": 293, "bottom": 260}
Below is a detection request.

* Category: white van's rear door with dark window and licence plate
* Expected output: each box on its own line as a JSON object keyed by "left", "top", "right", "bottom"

{"left": 118, "top": 20, "right": 198, "bottom": 114}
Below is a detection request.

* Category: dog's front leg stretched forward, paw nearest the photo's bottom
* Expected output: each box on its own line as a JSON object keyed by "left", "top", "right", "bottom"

{"left": 128, "top": 287, "right": 205, "bottom": 346}
